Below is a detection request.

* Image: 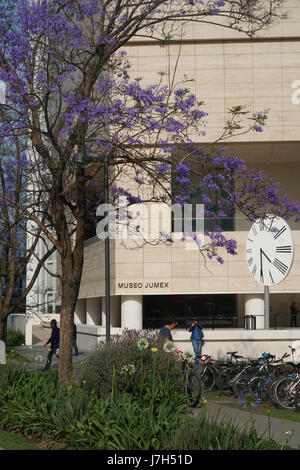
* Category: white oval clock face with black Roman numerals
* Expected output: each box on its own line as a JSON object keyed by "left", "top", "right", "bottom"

{"left": 246, "top": 216, "right": 294, "bottom": 286}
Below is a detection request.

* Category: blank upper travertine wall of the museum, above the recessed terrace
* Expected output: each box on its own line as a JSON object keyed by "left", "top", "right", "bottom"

{"left": 126, "top": 0, "right": 300, "bottom": 142}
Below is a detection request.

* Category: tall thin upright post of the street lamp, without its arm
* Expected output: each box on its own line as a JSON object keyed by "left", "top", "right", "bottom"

{"left": 104, "top": 155, "right": 110, "bottom": 342}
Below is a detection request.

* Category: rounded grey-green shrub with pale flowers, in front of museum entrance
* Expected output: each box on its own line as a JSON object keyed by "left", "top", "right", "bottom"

{"left": 82, "top": 330, "right": 184, "bottom": 398}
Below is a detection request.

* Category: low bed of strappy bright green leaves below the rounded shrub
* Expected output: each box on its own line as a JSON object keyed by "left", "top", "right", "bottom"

{"left": 0, "top": 366, "right": 186, "bottom": 450}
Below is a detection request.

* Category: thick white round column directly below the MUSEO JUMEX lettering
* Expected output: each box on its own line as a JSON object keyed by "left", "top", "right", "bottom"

{"left": 121, "top": 295, "right": 143, "bottom": 330}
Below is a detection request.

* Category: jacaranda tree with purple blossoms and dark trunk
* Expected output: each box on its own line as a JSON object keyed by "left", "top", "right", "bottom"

{"left": 0, "top": 0, "right": 299, "bottom": 384}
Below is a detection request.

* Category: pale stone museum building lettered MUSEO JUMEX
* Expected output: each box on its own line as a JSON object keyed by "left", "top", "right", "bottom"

{"left": 26, "top": 0, "right": 300, "bottom": 356}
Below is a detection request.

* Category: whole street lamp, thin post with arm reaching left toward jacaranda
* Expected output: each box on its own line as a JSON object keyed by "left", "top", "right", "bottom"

{"left": 72, "top": 152, "right": 110, "bottom": 342}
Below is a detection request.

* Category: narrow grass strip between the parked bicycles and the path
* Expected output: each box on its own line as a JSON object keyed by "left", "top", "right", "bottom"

{"left": 203, "top": 390, "right": 300, "bottom": 423}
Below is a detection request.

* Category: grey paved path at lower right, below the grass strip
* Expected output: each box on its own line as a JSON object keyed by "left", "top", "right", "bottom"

{"left": 195, "top": 401, "right": 300, "bottom": 449}
